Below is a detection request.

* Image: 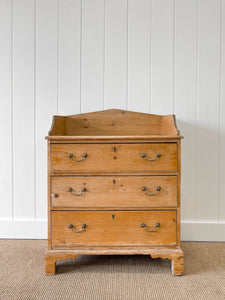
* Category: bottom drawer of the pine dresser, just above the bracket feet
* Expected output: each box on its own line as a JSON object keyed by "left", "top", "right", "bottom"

{"left": 52, "top": 211, "right": 177, "bottom": 249}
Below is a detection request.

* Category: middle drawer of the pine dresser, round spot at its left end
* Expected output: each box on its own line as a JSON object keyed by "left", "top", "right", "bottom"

{"left": 51, "top": 176, "right": 177, "bottom": 208}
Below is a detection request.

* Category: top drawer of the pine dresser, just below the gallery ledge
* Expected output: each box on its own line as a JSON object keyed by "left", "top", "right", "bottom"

{"left": 51, "top": 143, "right": 177, "bottom": 173}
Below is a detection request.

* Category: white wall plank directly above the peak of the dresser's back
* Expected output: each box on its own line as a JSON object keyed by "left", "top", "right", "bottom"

{"left": 104, "top": 0, "right": 128, "bottom": 109}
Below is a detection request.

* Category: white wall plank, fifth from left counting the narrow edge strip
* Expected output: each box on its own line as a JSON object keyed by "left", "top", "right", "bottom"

{"left": 81, "top": 0, "right": 104, "bottom": 112}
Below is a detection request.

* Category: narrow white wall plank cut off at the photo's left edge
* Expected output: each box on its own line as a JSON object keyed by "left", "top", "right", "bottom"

{"left": 0, "top": 0, "right": 12, "bottom": 218}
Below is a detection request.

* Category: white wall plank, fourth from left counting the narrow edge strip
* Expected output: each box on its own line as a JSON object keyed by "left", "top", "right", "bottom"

{"left": 58, "top": 0, "right": 81, "bottom": 115}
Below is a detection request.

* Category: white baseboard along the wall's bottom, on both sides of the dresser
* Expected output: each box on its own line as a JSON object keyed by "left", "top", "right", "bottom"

{"left": 0, "top": 219, "right": 225, "bottom": 242}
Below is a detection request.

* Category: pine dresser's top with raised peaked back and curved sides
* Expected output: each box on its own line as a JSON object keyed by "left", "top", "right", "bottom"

{"left": 46, "top": 109, "right": 182, "bottom": 141}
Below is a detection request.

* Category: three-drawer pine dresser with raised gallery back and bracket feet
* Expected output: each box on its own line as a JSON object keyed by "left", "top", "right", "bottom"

{"left": 45, "top": 109, "right": 184, "bottom": 275}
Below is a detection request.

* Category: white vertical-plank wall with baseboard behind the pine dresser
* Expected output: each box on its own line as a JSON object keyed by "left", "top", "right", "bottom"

{"left": 0, "top": 0, "right": 225, "bottom": 241}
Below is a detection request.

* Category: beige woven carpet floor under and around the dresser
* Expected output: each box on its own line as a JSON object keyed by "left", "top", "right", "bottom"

{"left": 0, "top": 240, "right": 225, "bottom": 300}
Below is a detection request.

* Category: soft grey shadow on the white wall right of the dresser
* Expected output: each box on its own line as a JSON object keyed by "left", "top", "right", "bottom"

{"left": 177, "top": 118, "right": 225, "bottom": 221}
